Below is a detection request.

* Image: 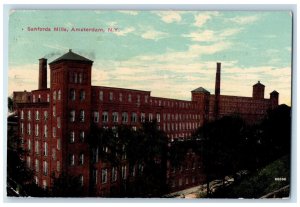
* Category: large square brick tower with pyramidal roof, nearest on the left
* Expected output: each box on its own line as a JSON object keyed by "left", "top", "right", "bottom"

{"left": 49, "top": 50, "right": 93, "bottom": 192}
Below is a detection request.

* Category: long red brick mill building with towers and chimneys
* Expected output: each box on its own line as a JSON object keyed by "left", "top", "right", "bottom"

{"left": 13, "top": 50, "right": 278, "bottom": 196}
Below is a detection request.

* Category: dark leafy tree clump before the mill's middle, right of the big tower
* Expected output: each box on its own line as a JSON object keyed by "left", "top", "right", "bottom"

{"left": 89, "top": 121, "right": 167, "bottom": 197}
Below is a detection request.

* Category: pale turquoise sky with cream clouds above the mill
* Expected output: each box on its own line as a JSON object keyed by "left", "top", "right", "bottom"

{"left": 8, "top": 10, "right": 292, "bottom": 105}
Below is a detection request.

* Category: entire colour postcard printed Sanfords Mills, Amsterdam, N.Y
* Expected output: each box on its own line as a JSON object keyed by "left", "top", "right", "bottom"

{"left": 6, "top": 10, "right": 293, "bottom": 199}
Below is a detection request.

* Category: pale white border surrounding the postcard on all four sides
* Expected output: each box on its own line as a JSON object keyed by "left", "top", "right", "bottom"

{"left": 0, "top": 0, "right": 299, "bottom": 206}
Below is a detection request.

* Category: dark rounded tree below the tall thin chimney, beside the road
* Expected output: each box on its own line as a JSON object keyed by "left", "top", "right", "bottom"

{"left": 193, "top": 116, "right": 246, "bottom": 196}
